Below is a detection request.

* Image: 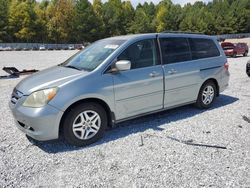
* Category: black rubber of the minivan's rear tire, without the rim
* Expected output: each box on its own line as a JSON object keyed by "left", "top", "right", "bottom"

{"left": 195, "top": 81, "right": 217, "bottom": 109}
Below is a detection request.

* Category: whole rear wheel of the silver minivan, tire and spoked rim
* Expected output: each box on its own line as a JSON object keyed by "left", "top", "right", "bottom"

{"left": 196, "top": 81, "right": 217, "bottom": 109}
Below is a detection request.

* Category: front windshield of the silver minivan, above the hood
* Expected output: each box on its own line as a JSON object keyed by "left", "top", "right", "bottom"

{"left": 61, "top": 39, "right": 125, "bottom": 71}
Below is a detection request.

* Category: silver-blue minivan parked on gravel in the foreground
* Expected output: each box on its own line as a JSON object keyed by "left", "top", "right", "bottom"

{"left": 9, "top": 33, "right": 229, "bottom": 146}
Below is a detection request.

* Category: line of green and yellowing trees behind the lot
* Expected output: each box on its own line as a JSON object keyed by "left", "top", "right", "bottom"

{"left": 0, "top": 0, "right": 250, "bottom": 43}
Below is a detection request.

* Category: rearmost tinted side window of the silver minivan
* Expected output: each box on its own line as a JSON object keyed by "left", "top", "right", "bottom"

{"left": 189, "top": 38, "right": 220, "bottom": 59}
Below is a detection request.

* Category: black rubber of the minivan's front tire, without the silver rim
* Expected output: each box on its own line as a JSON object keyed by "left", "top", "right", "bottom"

{"left": 63, "top": 102, "right": 108, "bottom": 146}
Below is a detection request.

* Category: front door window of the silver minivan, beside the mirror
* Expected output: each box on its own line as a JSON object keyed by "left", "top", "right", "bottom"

{"left": 117, "top": 39, "right": 157, "bottom": 69}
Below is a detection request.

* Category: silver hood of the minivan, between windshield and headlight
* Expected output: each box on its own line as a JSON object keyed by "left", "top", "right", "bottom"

{"left": 16, "top": 66, "right": 89, "bottom": 95}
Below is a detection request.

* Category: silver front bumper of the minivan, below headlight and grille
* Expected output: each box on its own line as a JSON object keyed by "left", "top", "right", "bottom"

{"left": 9, "top": 102, "right": 63, "bottom": 141}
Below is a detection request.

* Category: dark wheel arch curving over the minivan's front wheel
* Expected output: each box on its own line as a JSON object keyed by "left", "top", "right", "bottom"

{"left": 59, "top": 98, "right": 115, "bottom": 135}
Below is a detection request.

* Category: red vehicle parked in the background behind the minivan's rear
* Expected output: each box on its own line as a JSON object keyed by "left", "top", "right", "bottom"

{"left": 221, "top": 42, "right": 249, "bottom": 57}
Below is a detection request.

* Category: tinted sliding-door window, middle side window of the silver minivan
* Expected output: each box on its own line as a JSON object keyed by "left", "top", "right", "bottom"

{"left": 160, "top": 38, "right": 191, "bottom": 64}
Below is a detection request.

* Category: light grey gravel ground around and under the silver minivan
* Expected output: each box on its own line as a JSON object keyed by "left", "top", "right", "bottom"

{"left": 0, "top": 51, "right": 250, "bottom": 187}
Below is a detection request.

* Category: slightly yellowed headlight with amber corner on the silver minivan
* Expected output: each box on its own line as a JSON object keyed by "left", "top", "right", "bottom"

{"left": 23, "top": 88, "right": 58, "bottom": 108}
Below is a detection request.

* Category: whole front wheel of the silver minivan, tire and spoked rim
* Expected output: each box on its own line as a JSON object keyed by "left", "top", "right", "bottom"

{"left": 63, "top": 102, "right": 108, "bottom": 146}
